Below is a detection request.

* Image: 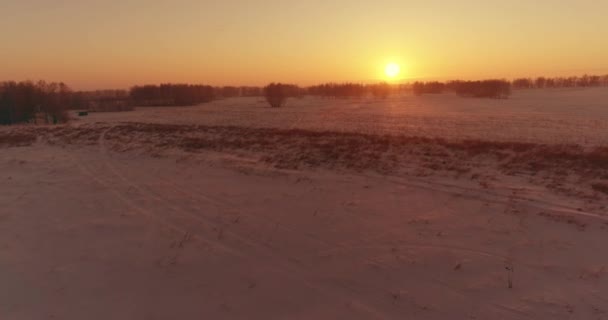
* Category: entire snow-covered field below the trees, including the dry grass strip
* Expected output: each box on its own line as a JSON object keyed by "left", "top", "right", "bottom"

{"left": 0, "top": 88, "right": 608, "bottom": 319}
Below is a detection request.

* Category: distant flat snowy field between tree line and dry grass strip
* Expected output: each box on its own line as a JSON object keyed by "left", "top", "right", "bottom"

{"left": 79, "top": 88, "right": 608, "bottom": 145}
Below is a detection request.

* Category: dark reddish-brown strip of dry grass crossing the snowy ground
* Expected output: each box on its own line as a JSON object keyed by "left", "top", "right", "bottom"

{"left": 0, "top": 123, "right": 608, "bottom": 198}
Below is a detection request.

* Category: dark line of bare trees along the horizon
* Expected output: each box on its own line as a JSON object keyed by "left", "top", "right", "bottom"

{"left": 0, "top": 75, "right": 608, "bottom": 124}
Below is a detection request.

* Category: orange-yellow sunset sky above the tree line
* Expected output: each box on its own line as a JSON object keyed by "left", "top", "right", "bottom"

{"left": 0, "top": 0, "right": 608, "bottom": 90}
